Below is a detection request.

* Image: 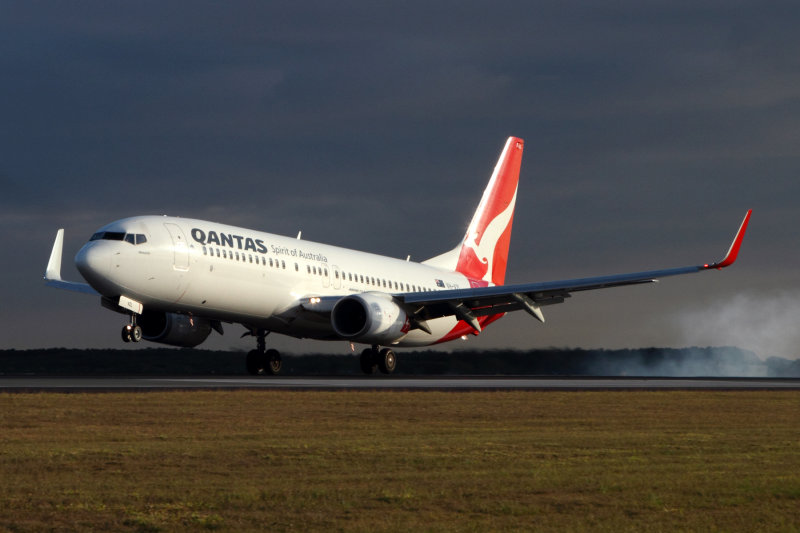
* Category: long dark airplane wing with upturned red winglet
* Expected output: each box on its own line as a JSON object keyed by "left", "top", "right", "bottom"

{"left": 394, "top": 209, "right": 752, "bottom": 331}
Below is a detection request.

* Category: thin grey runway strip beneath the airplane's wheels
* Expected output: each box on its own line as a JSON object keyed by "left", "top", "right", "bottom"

{"left": 0, "top": 376, "right": 800, "bottom": 392}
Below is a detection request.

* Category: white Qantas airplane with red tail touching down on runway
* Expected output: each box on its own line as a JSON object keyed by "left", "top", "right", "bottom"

{"left": 44, "top": 137, "right": 752, "bottom": 375}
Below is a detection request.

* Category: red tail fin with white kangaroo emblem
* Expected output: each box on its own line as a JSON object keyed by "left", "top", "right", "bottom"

{"left": 456, "top": 137, "right": 525, "bottom": 285}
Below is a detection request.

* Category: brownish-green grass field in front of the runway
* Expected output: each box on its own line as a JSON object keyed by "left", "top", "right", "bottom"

{"left": 0, "top": 391, "right": 800, "bottom": 531}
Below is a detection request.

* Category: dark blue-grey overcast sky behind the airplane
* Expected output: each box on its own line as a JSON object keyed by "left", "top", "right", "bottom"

{"left": 0, "top": 0, "right": 800, "bottom": 357}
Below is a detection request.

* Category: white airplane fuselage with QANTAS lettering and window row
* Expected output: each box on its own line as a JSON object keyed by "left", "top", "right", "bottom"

{"left": 75, "top": 216, "right": 470, "bottom": 346}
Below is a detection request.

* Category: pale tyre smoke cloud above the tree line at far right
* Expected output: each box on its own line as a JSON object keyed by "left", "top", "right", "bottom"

{"left": 675, "top": 291, "right": 800, "bottom": 360}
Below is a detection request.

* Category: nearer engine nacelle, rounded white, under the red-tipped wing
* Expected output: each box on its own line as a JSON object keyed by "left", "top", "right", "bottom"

{"left": 331, "top": 292, "right": 409, "bottom": 346}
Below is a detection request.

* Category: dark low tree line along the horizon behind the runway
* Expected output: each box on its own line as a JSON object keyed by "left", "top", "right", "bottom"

{"left": 0, "top": 347, "right": 800, "bottom": 378}
